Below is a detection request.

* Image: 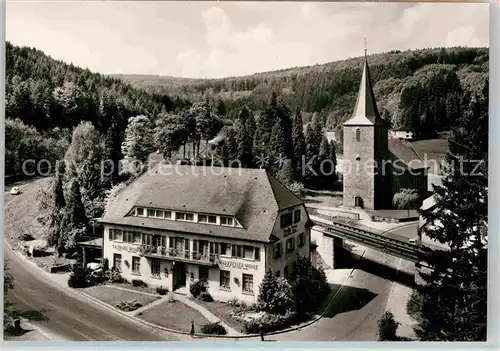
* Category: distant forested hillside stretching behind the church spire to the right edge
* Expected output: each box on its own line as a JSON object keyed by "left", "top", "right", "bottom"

{"left": 113, "top": 48, "right": 488, "bottom": 138}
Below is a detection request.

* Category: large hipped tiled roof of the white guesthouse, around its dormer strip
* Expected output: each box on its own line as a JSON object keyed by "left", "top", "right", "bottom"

{"left": 99, "top": 164, "right": 302, "bottom": 242}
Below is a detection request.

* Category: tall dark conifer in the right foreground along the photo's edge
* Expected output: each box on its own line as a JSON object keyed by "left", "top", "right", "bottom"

{"left": 415, "top": 90, "right": 488, "bottom": 341}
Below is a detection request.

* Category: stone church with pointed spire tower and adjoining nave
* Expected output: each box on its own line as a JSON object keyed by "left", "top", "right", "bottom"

{"left": 342, "top": 56, "right": 427, "bottom": 210}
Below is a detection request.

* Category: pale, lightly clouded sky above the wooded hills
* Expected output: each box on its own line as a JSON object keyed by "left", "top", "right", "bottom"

{"left": 6, "top": 0, "right": 489, "bottom": 78}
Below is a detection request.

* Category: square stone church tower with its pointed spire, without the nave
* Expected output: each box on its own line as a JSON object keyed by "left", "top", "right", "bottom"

{"left": 342, "top": 53, "right": 392, "bottom": 209}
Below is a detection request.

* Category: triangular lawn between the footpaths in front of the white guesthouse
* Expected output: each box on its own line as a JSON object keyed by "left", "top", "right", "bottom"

{"left": 138, "top": 301, "right": 209, "bottom": 333}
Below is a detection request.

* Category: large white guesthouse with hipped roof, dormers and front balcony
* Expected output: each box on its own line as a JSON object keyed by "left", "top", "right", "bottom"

{"left": 99, "top": 164, "right": 310, "bottom": 302}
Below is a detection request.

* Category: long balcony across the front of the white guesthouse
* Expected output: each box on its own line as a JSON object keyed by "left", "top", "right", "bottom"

{"left": 140, "top": 245, "right": 219, "bottom": 266}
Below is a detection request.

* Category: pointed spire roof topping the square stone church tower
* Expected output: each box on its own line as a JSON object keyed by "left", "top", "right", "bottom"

{"left": 344, "top": 55, "right": 387, "bottom": 126}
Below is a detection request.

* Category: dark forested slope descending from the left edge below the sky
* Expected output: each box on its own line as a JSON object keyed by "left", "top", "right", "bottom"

{"left": 5, "top": 42, "right": 185, "bottom": 174}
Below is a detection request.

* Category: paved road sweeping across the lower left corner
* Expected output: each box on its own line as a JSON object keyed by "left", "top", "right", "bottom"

{"left": 4, "top": 179, "right": 183, "bottom": 341}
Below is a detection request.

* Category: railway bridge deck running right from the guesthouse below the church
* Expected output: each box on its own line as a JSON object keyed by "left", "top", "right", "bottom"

{"left": 311, "top": 216, "right": 427, "bottom": 264}
